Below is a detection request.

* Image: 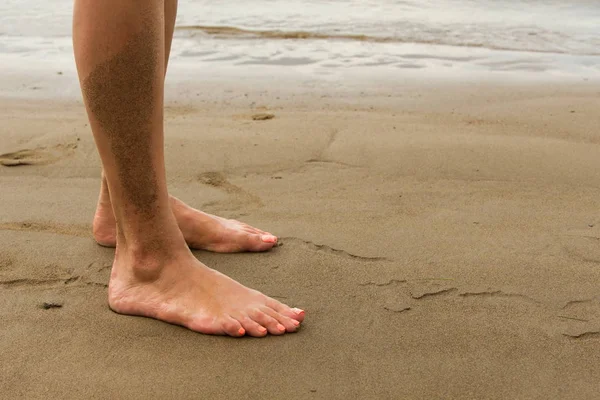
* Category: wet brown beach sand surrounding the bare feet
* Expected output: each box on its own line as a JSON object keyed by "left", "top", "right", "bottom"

{"left": 0, "top": 79, "right": 600, "bottom": 399}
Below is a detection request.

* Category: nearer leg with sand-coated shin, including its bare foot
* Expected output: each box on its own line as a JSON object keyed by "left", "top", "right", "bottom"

{"left": 73, "top": 0, "right": 304, "bottom": 336}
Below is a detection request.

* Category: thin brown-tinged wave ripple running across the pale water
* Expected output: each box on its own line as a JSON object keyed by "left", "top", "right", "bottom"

{"left": 175, "top": 25, "right": 600, "bottom": 56}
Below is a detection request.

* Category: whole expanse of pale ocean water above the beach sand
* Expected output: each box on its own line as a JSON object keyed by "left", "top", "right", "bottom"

{"left": 0, "top": 0, "right": 600, "bottom": 86}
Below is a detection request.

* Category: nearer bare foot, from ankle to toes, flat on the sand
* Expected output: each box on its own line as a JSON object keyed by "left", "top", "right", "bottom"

{"left": 108, "top": 248, "right": 304, "bottom": 337}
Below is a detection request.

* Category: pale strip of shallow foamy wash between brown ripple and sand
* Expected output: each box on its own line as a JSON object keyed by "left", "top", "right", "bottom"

{"left": 0, "top": 38, "right": 600, "bottom": 100}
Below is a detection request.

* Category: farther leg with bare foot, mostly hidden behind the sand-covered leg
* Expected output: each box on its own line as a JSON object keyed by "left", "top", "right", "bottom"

{"left": 93, "top": 0, "right": 277, "bottom": 253}
